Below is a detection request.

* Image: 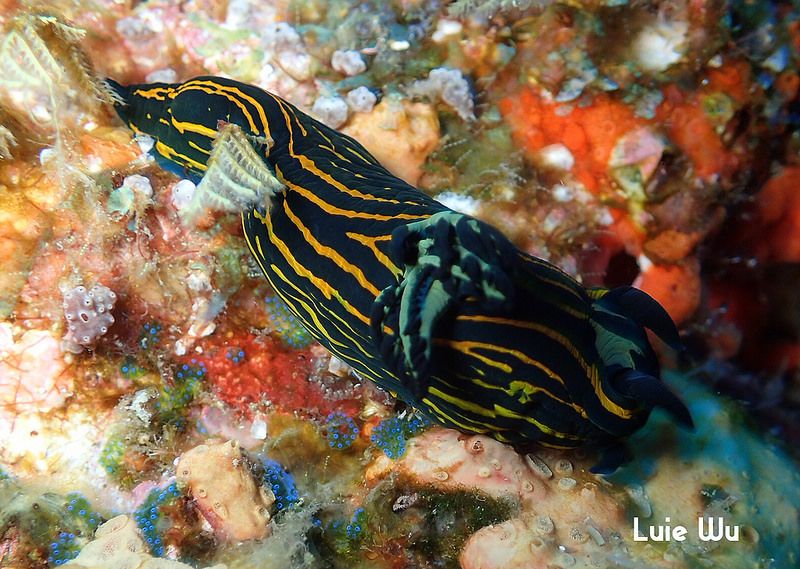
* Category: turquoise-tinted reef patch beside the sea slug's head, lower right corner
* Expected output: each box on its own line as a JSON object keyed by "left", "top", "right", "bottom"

{"left": 607, "top": 372, "right": 800, "bottom": 568}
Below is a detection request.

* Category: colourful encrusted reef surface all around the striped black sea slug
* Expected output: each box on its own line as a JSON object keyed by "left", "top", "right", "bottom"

{"left": 0, "top": 0, "right": 800, "bottom": 569}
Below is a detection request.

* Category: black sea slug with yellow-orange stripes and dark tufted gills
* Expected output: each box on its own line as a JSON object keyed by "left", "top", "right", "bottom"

{"left": 108, "top": 77, "right": 692, "bottom": 472}
